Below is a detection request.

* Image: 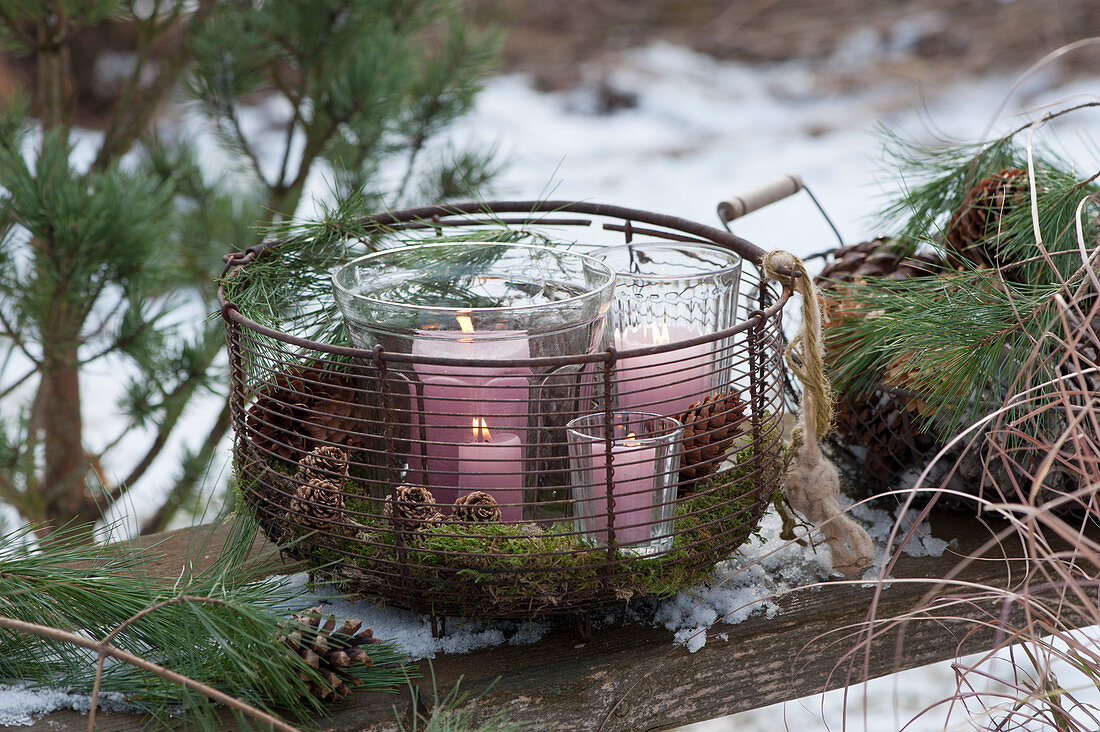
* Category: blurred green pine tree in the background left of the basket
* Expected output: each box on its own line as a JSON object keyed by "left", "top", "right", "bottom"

{"left": 0, "top": 0, "right": 497, "bottom": 531}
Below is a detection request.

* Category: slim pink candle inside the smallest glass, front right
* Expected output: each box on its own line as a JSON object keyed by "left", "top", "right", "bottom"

{"left": 587, "top": 433, "right": 658, "bottom": 544}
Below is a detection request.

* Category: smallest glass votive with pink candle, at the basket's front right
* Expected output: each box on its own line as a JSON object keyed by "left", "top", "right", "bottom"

{"left": 567, "top": 412, "right": 683, "bottom": 557}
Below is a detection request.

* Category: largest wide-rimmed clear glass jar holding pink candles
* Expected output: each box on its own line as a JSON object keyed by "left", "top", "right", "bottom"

{"left": 333, "top": 242, "right": 615, "bottom": 522}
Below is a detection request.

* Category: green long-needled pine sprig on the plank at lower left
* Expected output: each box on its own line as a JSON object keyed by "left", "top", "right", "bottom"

{"left": 0, "top": 516, "right": 407, "bottom": 729}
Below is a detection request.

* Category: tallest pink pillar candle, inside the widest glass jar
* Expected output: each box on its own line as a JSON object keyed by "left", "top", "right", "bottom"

{"left": 410, "top": 316, "right": 532, "bottom": 505}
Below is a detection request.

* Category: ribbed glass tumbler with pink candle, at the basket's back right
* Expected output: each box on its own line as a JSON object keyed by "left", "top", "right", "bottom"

{"left": 592, "top": 241, "right": 741, "bottom": 416}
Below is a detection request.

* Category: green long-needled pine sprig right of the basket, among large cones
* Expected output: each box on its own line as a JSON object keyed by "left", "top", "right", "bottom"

{"left": 829, "top": 112, "right": 1098, "bottom": 435}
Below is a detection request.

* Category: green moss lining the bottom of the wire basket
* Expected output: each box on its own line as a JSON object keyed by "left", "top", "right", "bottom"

{"left": 248, "top": 448, "right": 771, "bottom": 618}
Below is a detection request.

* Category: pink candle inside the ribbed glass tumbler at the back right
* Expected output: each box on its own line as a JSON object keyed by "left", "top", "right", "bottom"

{"left": 615, "top": 323, "right": 714, "bottom": 417}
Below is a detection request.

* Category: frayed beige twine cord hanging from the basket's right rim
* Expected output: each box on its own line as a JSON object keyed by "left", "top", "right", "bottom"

{"left": 763, "top": 250, "right": 875, "bottom": 577}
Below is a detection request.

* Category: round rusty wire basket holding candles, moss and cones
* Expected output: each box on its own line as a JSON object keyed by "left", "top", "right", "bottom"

{"left": 220, "top": 201, "right": 790, "bottom": 618}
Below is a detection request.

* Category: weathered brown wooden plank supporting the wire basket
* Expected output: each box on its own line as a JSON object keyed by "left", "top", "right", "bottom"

{"left": 27, "top": 516, "right": 1047, "bottom": 732}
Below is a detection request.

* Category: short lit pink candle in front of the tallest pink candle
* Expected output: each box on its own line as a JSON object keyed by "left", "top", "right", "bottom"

{"left": 459, "top": 417, "right": 524, "bottom": 521}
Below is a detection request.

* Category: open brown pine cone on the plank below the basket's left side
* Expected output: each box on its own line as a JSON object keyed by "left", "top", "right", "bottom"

{"left": 277, "top": 605, "right": 382, "bottom": 699}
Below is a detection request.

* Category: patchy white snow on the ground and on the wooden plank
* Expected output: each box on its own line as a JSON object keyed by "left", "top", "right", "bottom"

{"left": 0, "top": 36, "right": 1100, "bottom": 732}
